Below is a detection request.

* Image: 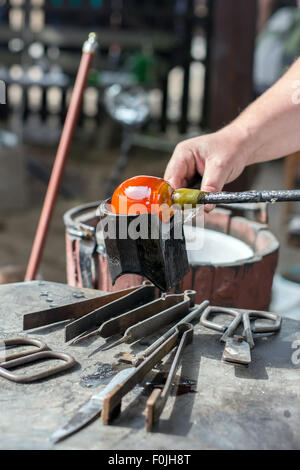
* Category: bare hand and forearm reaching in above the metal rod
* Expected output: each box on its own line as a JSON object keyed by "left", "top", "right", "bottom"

{"left": 164, "top": 58, "right": 300, "bottom": 210}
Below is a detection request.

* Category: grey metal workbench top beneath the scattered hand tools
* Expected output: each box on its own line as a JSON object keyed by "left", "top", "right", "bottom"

{"left": 0, "top": 281, "right": 300, "bottom": 450}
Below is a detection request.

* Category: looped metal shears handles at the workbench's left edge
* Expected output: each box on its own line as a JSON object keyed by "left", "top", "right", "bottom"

{"left": 0, "top": 338, "right": 76, "bottom": 383}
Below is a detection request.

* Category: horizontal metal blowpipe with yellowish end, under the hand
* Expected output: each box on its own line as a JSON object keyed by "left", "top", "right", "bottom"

{"left": 172, "top": 189, "right": 300, "bottom": 207}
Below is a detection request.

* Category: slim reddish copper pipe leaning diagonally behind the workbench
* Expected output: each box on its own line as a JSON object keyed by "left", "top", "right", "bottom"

{"left": 25, "top": 33, "right": 97, "bottom": 281}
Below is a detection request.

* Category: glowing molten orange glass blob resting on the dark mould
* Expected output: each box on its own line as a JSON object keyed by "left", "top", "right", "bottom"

{"left": 111, "top": 176, "right": 174, "bottom": 218}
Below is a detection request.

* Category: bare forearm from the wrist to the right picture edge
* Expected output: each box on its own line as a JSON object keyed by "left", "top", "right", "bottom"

{"left": 227, "top": 59, "right": 300, "bottom": 165}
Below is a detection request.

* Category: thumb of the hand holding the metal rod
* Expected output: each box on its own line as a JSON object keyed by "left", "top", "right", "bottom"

{"left": 201, "top": 159, "right": 231, "bottom": 212}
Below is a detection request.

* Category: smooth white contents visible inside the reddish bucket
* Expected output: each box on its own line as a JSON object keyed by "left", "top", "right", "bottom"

{"left": 184, "top": 225, "right": 254, "bottom": 265}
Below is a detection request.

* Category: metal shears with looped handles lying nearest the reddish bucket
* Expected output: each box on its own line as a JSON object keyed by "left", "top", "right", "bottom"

{"left": 200, "top": 306, "right": 281, "bottom": 364}
